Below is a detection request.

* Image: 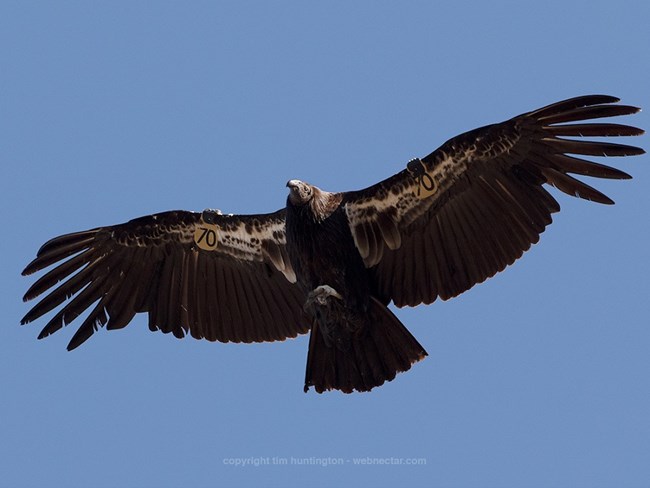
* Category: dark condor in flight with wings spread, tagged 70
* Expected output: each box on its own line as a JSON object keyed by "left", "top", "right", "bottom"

{"left": 21, "top": 95, "right": 644, "bottom": 393}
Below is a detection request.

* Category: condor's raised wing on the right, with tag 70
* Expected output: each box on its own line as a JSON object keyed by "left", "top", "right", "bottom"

{"left": 342, "top": 95, "right": 644, "bottom": 306}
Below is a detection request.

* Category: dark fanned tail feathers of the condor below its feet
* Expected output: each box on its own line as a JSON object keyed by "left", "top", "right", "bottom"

{"left": 305, "top": 298, "right": 427, "bottom": 393}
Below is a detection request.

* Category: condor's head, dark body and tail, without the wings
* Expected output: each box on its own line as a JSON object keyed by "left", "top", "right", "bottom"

{"left": 286, "top": 180, "right": 426, "bottom": 393}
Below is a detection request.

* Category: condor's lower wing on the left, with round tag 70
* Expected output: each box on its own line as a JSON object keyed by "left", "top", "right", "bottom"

{"left": 21, "top": 210, "right": 308, "bottom": 350}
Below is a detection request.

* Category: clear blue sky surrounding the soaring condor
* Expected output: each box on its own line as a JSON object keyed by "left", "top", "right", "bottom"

{"left": 0, "top": 1, "right": 650, "bottom": 487}
